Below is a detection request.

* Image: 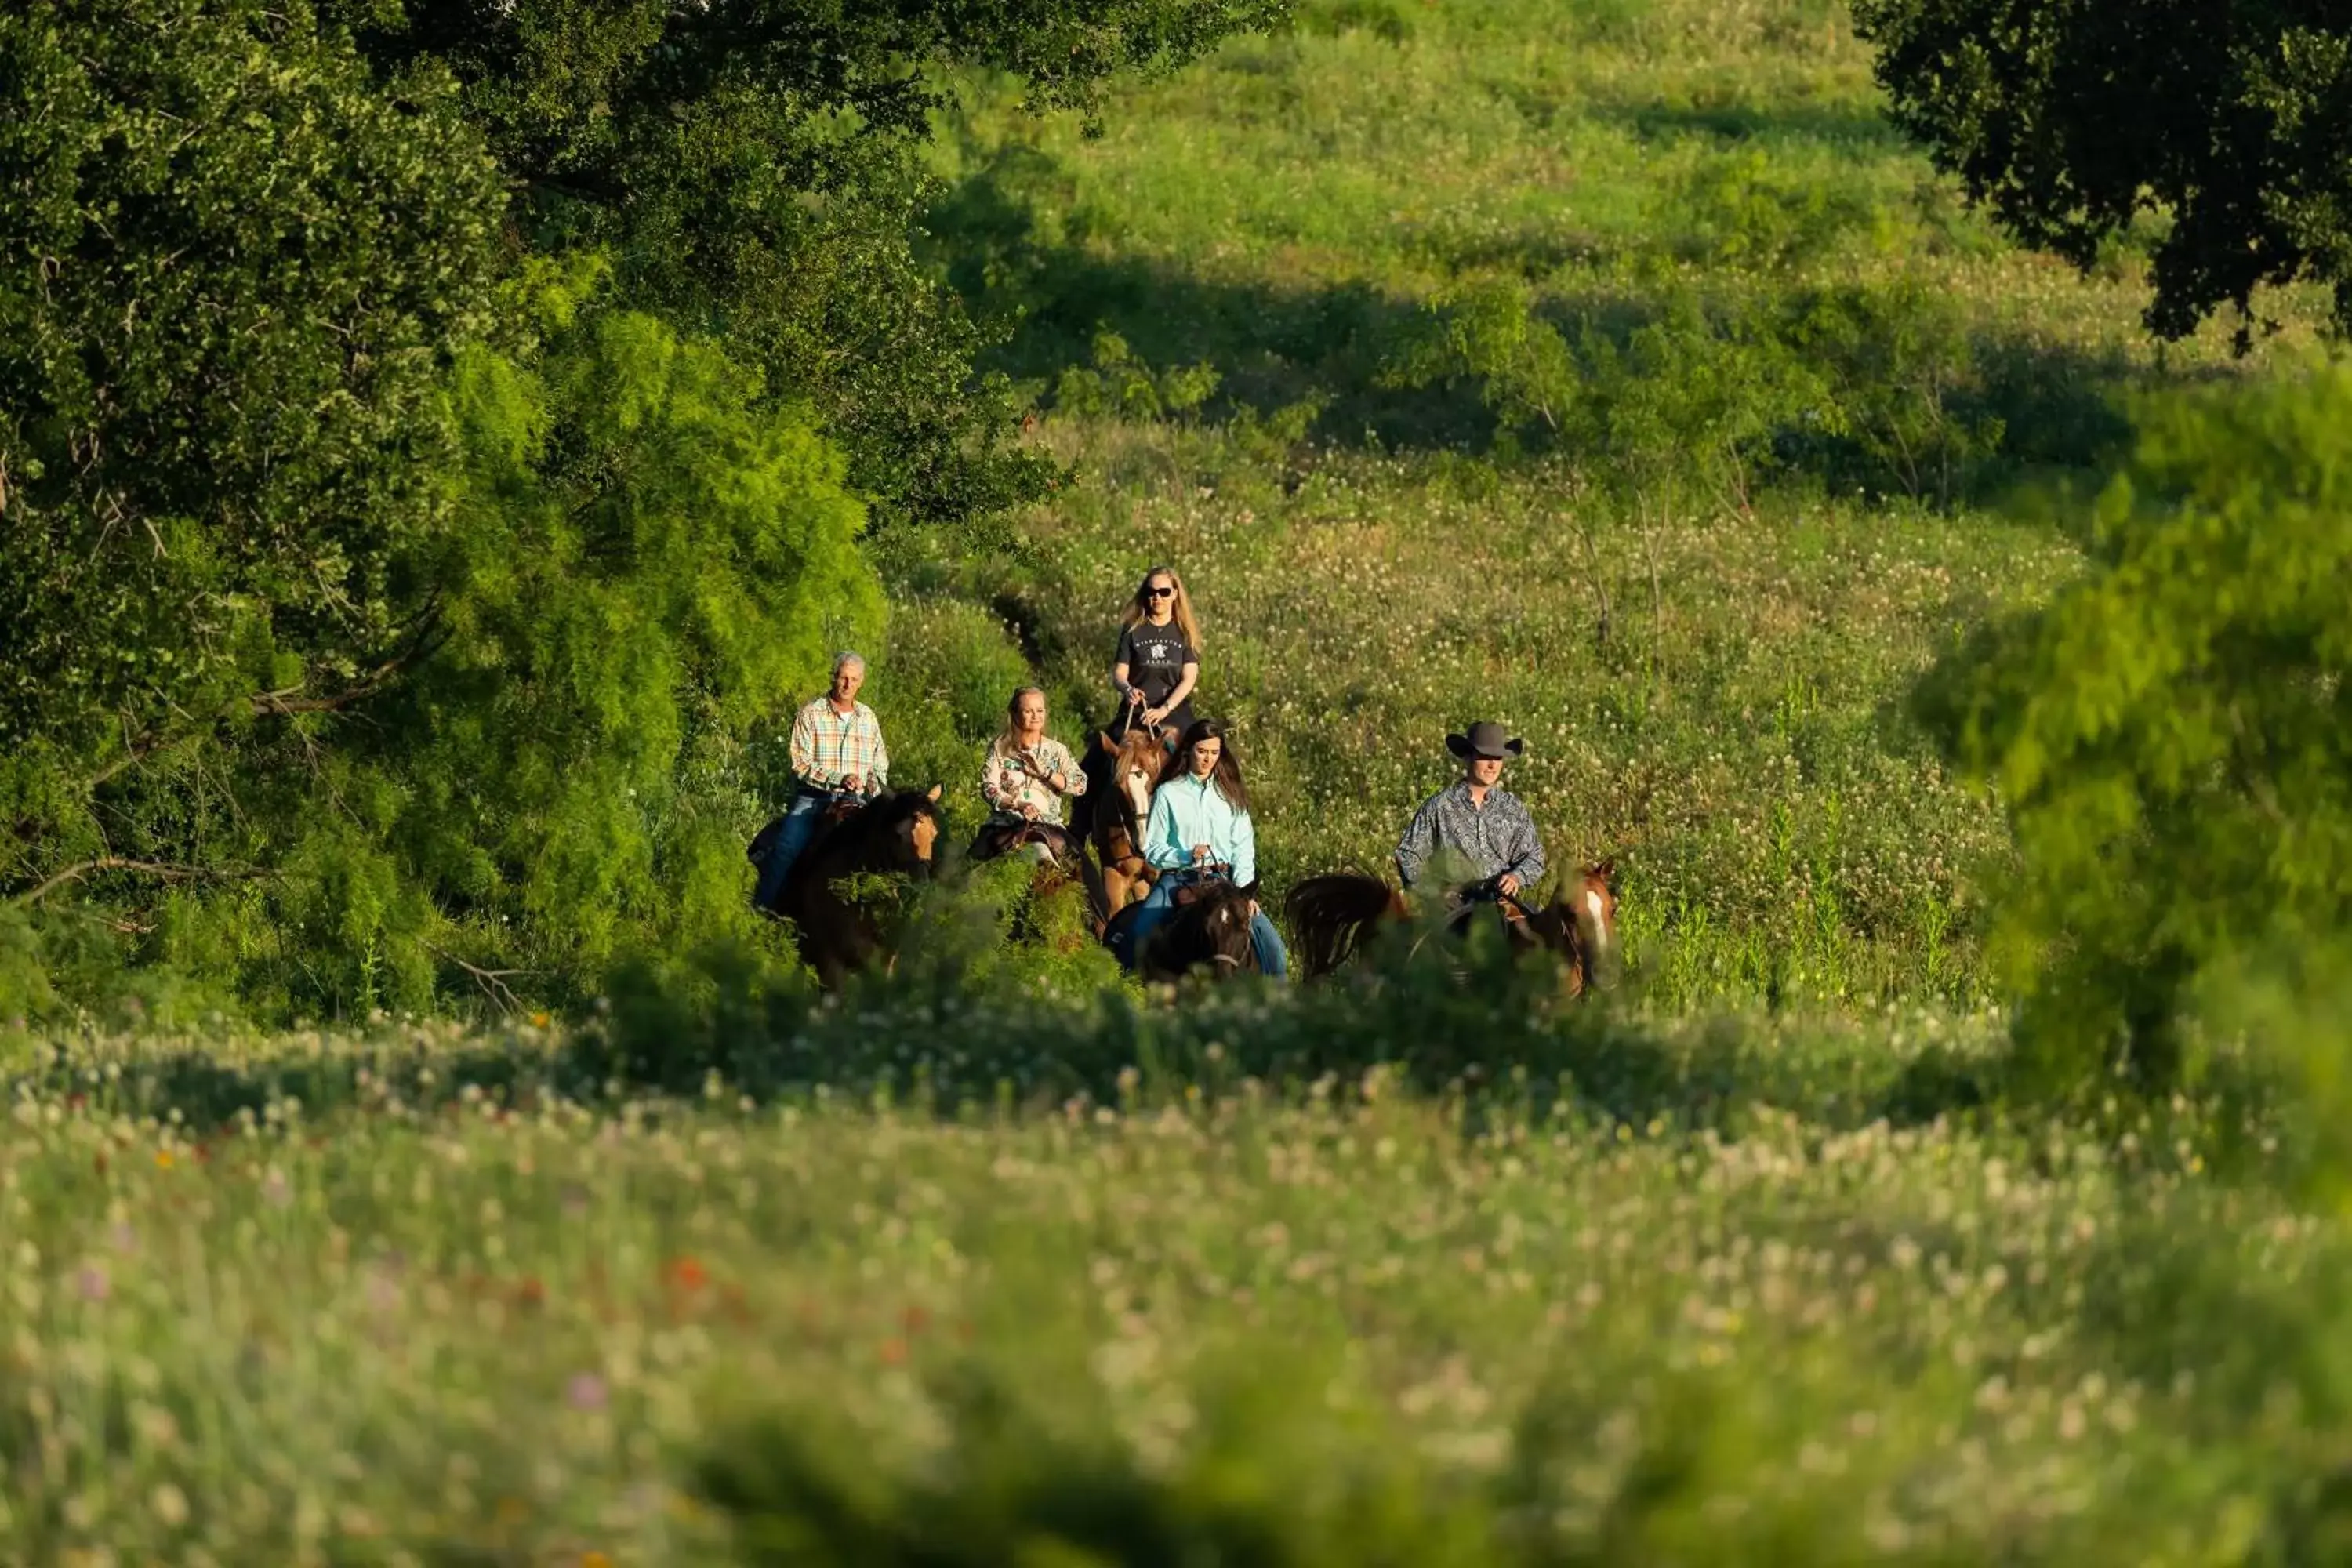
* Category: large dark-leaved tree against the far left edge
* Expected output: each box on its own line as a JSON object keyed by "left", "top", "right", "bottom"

{"left": 0, "top": 0, "right": 499, "bottom": 931}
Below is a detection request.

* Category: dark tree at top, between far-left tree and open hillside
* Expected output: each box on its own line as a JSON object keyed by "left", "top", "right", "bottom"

{"left": 327, "top": 0, "right": 1287, "bottom": 533}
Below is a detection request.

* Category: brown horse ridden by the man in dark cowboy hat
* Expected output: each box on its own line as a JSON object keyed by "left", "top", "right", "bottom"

{"left": 1282, "top": 860, "right": 1616, "bottom": 996}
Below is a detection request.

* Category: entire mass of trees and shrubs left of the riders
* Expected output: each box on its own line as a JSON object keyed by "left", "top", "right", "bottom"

{"left": 0, "top": 0, "right": 1289, "bottom": 1015}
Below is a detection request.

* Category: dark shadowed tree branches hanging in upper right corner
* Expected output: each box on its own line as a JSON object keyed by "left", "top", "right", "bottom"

{"left": 1853, "top": 0, "right": 2352, "bottom": 348}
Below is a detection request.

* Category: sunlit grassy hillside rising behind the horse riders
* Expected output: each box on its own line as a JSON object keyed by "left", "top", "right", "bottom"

{"left": 877, "top": 0, "right": 2300, "bottom": 1001}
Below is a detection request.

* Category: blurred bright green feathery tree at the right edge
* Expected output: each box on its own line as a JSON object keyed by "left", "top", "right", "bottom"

{"left": 1917, "top": 365, "right": 2352, "bottom": 1083}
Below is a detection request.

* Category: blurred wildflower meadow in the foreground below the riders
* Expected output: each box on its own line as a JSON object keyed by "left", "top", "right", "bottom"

{"left": 0, "top": 971, "right": 2352, "bottom": 1563}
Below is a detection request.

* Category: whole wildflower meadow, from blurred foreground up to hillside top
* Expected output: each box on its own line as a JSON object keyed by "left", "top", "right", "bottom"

{"left": 0, "top": 0, "right": 2352, "bottom": 1568}
